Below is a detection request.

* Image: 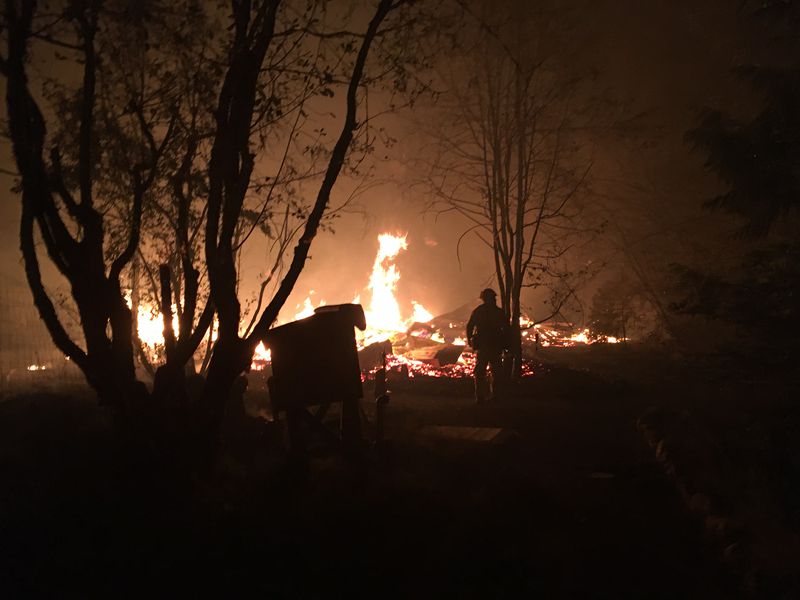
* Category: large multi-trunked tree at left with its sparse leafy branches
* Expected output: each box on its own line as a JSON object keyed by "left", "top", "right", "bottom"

{"left": 0, "top": 0, "right": 413, "bottom": 460}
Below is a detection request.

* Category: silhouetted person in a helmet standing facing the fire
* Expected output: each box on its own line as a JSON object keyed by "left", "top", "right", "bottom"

{"left": 467, "top": 288, "right": 508, "bottom": 404}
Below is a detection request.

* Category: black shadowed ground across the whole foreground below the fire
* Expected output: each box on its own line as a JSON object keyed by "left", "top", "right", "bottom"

{"left": 0, "top": 345, "right": 800, "bottom": 598}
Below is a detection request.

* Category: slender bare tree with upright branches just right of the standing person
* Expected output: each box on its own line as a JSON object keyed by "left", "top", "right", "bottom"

{"left": 428, "top": 2, "right": 591, "bottom": 375}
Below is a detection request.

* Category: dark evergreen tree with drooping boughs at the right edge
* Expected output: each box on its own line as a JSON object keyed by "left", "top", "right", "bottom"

{"left": 672, "top": 0, "right": 800, "bottom": 356}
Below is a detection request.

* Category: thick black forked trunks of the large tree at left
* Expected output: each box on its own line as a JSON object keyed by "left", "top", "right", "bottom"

{"left": 0, "top": 0, "right": 404, "bottom": 468}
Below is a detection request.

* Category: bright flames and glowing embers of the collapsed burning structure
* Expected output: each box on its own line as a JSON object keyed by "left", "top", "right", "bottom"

{"left": 0, "top": 233, "right": 619, "bottom": 396}
